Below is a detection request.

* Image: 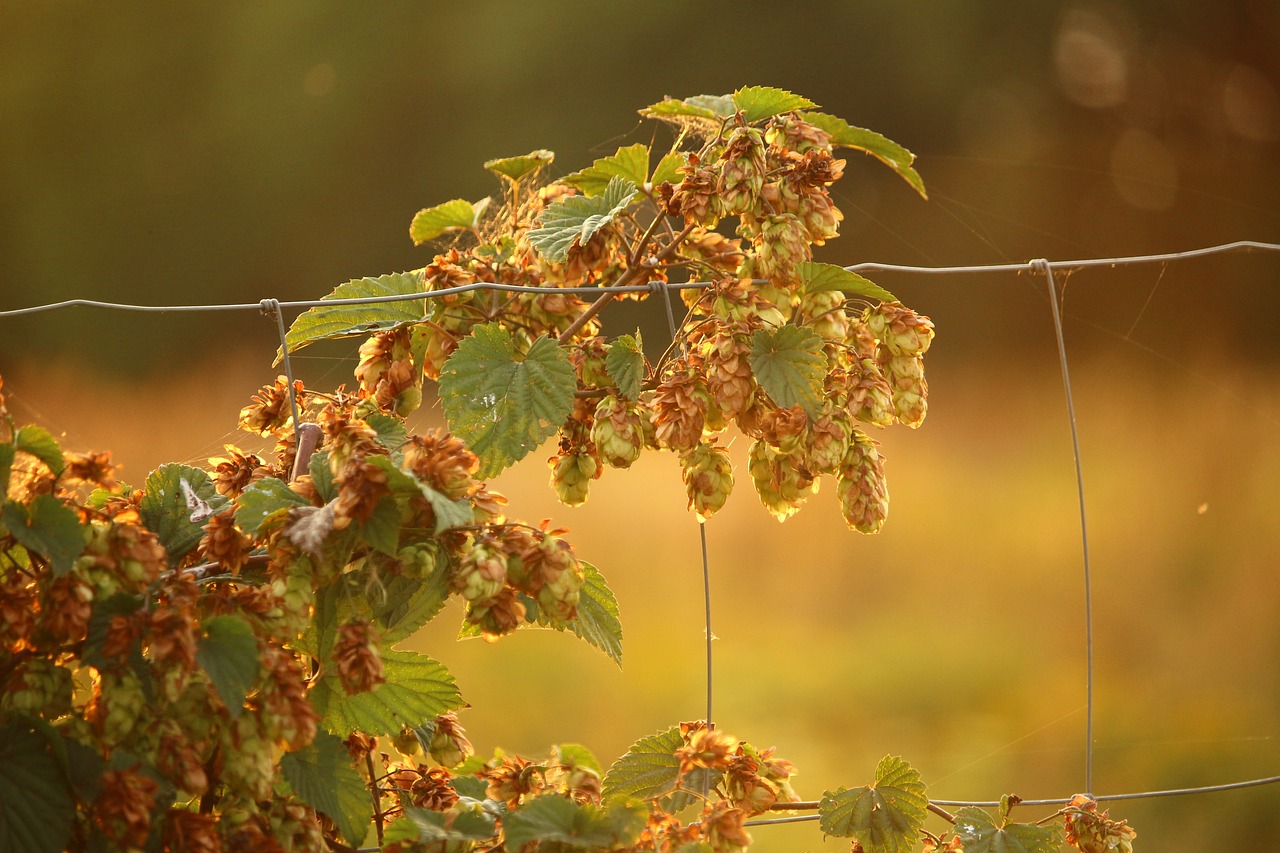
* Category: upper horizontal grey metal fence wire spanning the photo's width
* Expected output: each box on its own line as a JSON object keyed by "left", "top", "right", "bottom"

{"left": 0, "top": 240, "right": 1280, "bottom": 318}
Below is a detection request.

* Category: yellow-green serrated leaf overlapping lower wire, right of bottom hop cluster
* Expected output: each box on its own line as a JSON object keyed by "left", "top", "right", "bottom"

{"left": 818, "top": 756, "right": 931, "bottom": 853}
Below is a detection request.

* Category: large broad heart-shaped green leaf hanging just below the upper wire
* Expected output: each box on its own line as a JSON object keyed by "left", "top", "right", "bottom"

{"left": 440, "top": 323, "right": 577, "bottom": 479}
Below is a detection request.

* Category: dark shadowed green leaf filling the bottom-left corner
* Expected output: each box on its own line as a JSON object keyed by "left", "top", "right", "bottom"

{"left": 0, "top": 722, "right": 76, "bottom": 853}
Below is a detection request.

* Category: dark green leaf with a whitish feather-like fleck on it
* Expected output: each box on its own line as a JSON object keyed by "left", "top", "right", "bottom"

{"left": 140, "top": 464, "right": 230, "bottom": 562}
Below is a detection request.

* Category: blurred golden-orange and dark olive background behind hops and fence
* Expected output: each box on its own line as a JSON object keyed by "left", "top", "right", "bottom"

{"left": 0, "top": 0, "right": 1280, "bottom": 853}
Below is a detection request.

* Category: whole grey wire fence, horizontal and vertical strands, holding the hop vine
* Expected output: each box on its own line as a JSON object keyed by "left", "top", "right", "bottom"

{"left": 0, "top": 240, "right": 1280, "bottom": 826}
